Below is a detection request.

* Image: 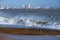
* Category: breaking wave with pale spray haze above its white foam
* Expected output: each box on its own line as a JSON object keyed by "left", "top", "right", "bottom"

{"left": 0, "top": 14, "right": 60, "bottom": 29}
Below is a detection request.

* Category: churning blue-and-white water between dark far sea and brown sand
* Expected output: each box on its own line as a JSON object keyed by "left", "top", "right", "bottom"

{"left": 0, "top": 11, "right": 60, "bottom": 29}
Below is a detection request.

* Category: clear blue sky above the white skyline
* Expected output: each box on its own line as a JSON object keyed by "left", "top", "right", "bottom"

{"left": 0, "top": 0, "right": 60, "bottom": 7}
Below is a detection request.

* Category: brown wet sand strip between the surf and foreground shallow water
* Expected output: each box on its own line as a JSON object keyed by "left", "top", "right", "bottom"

{"left": 0, "top": 28, "right": 60, "bottom": 35}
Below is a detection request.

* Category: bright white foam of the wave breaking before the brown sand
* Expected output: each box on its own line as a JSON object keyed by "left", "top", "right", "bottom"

{"left": 0, "top": 15, "right": 60, "bottom": 29}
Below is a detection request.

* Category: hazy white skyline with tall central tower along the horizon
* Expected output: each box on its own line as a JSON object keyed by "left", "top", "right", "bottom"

{"left": 0, "top": 3, "right": 60, "bottom": 9}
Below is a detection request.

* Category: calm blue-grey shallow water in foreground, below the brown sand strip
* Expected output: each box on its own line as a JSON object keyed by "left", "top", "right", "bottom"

{"left": 2, "top": 34, "right": 60, "bottom": 40}
